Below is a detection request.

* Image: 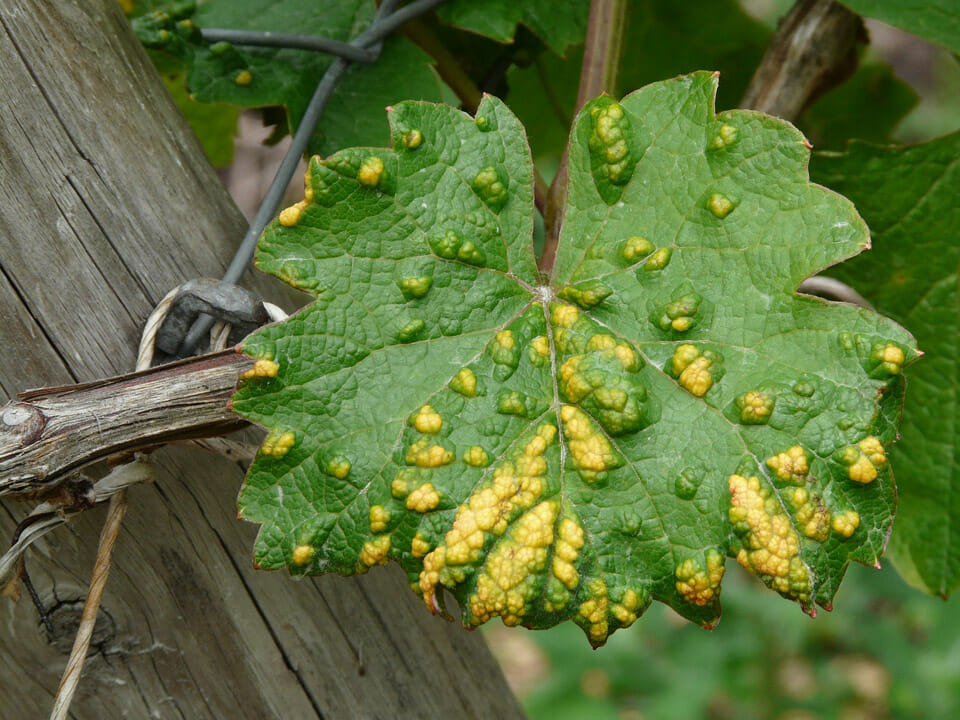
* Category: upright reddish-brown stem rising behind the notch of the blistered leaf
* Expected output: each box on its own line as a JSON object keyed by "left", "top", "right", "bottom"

{"left": 540, "top": 0, "right": 627, "bottom": 276}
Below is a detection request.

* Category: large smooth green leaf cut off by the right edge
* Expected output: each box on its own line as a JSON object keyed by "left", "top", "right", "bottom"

{"left": 813, "top": 133, "right": 960, "bottom": 595}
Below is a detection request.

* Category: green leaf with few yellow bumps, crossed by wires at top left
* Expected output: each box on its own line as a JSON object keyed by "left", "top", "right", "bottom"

{"left": 133, "top": 0, "right": 442, "bottom": 154}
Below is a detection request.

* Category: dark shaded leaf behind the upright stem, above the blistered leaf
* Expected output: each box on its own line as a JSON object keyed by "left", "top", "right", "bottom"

{"left": 507, "top": 0, "right": 770, "bottom": 162}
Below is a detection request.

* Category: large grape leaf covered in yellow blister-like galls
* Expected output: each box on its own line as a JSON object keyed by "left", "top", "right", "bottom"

{"left": 233, "top": 73, "right": 915, "bottom": 645}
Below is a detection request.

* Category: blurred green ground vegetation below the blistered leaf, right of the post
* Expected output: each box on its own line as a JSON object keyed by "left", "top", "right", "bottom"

{"left": 487, "top": 564, "right": 960, "bottom": 720}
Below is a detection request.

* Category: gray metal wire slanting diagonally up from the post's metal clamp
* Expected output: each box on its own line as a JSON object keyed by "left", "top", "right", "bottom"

{"left": 179, "top": 0, "right": 445, "bottom": 356}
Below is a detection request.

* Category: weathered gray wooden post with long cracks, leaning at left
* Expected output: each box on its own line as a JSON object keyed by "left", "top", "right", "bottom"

{"left": 0, "top": 0, "right": 522, "bottom": 720}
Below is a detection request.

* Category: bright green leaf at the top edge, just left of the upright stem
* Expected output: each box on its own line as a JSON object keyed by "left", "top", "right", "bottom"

{"left": 437, "top": 0, "right": 590, "bottom": 55}
